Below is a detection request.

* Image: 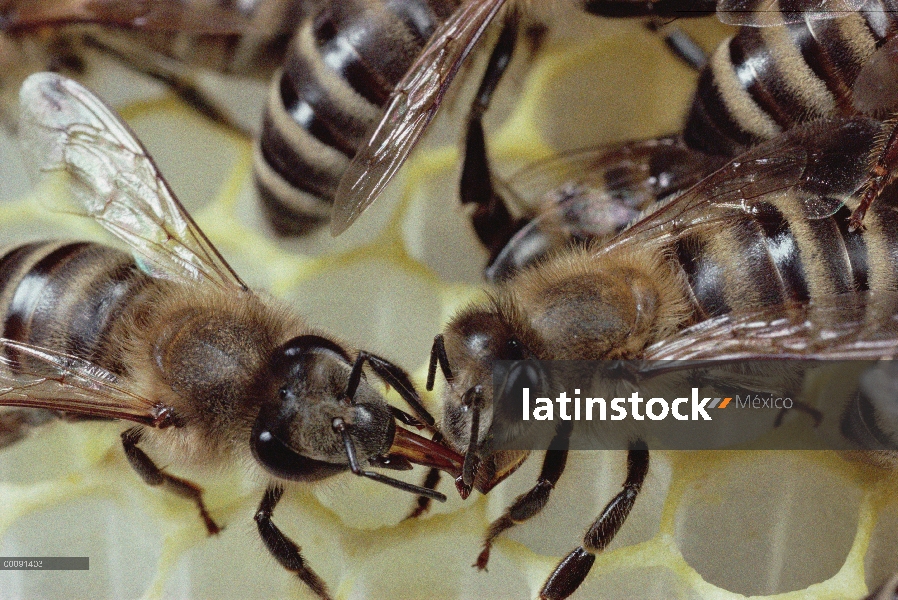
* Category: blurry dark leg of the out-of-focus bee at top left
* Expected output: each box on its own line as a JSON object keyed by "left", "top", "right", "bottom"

{"left": 79, "top": 36, "right": 253, "bottom": 137}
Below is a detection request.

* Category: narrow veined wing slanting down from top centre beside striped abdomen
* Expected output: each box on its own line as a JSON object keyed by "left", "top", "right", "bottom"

{"left": 331, "top": 0, "right": 505, "bottom": 235}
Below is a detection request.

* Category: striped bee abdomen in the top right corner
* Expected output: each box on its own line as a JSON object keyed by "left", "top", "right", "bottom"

{"left": 684, "top": 0, "right": 898, "bottom": 156}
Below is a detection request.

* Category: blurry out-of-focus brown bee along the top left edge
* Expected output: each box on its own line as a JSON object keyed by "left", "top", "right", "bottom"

{"left": 0, "top": 0, "right": 313, "bottom": 133}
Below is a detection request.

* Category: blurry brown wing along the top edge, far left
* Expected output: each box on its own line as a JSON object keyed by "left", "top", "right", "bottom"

{"left": 0, "top": 0, "right": 279, "bottom": 35}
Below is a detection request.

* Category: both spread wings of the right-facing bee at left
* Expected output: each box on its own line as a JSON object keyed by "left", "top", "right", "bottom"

{"left": 0, "top": 73, "right": 248, "bottom": 427}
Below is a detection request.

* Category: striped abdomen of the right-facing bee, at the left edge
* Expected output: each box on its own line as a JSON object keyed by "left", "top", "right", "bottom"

{"left": 0, "top": 242, "right": 149, "bottom": 367}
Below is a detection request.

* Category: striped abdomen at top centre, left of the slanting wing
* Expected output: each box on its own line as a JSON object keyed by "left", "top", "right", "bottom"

{"left": 255, "top": 0, "right": 458, "bottom": 235}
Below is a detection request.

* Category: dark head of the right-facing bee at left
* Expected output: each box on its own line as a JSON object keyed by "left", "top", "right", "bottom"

{"left": 251, "top": 335, "right": 396, "bottom": 481}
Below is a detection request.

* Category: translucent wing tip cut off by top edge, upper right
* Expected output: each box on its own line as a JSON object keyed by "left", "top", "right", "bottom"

{"left": 717, "top": 0, "right": 869, "bottom": 27}
